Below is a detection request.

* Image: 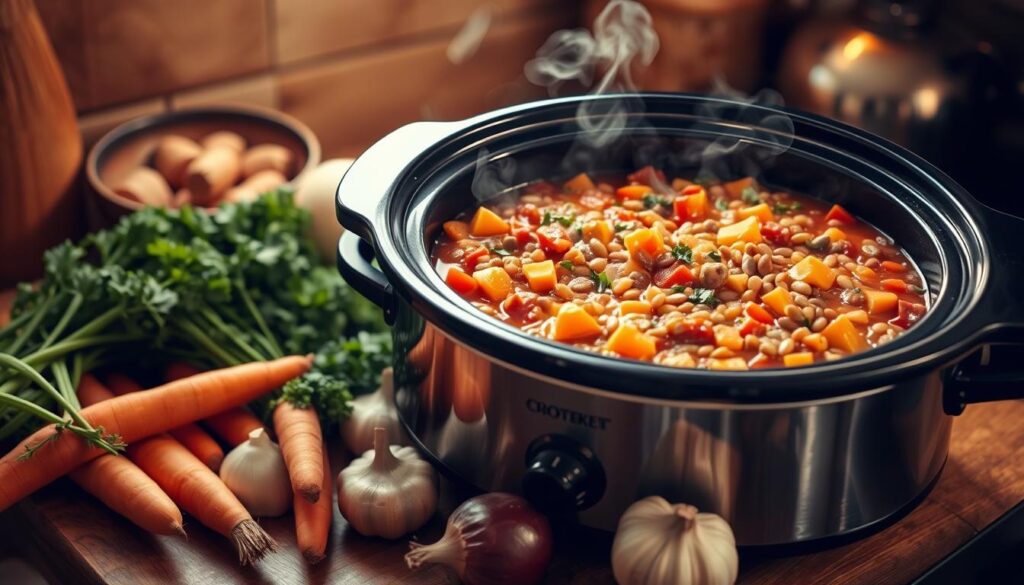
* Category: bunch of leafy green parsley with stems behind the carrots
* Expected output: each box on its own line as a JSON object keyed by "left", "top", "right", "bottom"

{"left": 0, "top": 191, "right": 391, "bottom": 450}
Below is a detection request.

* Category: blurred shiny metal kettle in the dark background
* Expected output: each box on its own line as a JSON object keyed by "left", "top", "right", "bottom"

{"left": 776, "top": 0, "right": 995, "bottom": 176}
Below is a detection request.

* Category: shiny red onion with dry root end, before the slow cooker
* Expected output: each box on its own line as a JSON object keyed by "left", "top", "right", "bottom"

{"left": 406, "top": 493, "right": 551, "bottom": 585}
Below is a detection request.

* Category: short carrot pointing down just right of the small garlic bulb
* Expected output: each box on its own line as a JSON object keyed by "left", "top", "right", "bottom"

{"left": 273, "top": 401, "right": 324, "bottom": 502}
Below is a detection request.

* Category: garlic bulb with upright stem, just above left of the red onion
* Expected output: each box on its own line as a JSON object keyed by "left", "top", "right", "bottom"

{"left": 338, "top": 426, "right": 437, "bottom": 538}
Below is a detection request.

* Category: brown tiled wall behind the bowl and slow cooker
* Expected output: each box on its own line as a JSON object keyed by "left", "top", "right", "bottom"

{"left": 36, "top": 0, "right": 579, "bottom": 157}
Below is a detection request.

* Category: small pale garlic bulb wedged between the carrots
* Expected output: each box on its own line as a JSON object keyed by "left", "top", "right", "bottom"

{"left": 220, "top": 427, "right": 292, "bottom": 516}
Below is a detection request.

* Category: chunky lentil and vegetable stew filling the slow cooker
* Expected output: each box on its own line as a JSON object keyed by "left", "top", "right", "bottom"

{"left": 433, "top": 167, "right": 927, "bottom": 370}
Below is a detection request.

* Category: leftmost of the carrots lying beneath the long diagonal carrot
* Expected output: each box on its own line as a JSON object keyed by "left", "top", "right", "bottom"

{"left": 70, "top": 374, "right": 185, "bottom": 536}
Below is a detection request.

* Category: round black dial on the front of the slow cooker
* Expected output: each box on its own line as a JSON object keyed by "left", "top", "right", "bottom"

{"left": 522, "top": 434, "right": 605, "bottom": 514}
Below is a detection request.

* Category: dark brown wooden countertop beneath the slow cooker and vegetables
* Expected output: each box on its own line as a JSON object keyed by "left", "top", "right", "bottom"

{"left": 6, "top": 401, "right": 1024, "bottom": 585}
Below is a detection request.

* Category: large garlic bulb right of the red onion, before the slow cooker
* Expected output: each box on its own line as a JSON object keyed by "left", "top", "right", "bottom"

{"left": 611, "top": 496, "right": 739, "bottom": 585}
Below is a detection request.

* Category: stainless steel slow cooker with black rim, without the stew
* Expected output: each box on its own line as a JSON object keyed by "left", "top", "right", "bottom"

{"left": 338, "top": 94, "right": 1024, "bottom": 545}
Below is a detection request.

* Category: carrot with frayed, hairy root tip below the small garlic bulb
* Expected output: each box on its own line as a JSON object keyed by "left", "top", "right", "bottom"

{"left": 80, "top": 380, "right": 276, "bottom": 565}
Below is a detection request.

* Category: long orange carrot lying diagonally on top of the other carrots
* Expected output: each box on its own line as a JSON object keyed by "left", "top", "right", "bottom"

{"left": 0, "top": 356, "right": 312, "bottom": 511}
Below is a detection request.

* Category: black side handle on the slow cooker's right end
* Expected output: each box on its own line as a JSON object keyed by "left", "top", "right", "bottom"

{"left": 944, "top": 208, "right": 1024, "bottom": 415}
